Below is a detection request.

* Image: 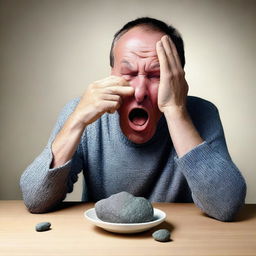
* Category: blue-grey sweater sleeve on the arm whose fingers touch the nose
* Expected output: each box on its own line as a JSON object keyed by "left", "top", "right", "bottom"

{"left": 20, "top": 99, "right": 83, "bottom": 213}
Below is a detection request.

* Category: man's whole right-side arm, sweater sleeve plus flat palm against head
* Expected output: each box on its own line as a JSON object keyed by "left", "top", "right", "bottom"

{"left": 156, "top": 36, "right": 246, "bottom": 221}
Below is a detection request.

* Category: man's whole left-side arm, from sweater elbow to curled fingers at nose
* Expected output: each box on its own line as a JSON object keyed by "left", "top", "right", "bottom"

{"left": 20, "top": 76, "right": 134, "bottom": 213}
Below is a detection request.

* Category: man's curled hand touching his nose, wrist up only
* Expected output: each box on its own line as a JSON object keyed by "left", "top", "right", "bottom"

{"left": 73, "top": 76, "right": 134, "bottom": 126}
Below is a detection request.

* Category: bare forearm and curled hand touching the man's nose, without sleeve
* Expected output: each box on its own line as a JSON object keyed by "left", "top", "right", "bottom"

{"left": 50, "top": 76, "right": 134, "bottom": 168}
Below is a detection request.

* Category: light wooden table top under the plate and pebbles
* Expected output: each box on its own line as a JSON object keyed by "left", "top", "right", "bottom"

{"left": 0, "top": 201, "right": 256, "bottom": 256}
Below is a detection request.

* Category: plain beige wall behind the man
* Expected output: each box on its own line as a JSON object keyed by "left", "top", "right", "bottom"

{"left": 0, "top": 0, "right": 256, "bottom": 203}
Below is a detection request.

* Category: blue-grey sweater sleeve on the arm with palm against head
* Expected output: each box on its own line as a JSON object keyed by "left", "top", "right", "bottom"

{"left": 175, "top": 100, "right": 246, "bottom": 221}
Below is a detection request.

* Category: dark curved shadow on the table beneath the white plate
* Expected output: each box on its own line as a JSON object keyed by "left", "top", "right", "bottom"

{"left": 93, "top": 221, "right": 175, "bottom": 241}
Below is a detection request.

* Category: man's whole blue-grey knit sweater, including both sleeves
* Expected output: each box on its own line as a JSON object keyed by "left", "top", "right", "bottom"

{"left": 20, "top": 96, "right": 246, "bottom": 221}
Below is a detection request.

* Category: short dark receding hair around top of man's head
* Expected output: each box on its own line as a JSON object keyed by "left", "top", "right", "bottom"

{"left": 110, "top": 17, "right": 185, "bottom": 68}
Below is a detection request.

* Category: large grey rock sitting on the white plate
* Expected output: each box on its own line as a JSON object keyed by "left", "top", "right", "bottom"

{"left": 95, "top": 191, "right": 154, "bottom": 223}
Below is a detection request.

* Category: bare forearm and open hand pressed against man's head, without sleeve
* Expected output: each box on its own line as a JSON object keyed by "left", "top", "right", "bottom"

{"left": 157, "top": 36, "right": 203, "bottom": 157}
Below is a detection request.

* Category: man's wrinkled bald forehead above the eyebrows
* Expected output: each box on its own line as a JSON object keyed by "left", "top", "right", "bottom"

{"left": 113, "top": 26, "right": 165, "bottom": 61}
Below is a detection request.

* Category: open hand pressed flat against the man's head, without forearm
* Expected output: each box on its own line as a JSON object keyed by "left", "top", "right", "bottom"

{"left": 156, "top": 35, "right": 188, "bottom": 113}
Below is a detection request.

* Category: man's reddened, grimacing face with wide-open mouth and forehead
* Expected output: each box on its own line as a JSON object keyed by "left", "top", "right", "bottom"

{"left": 111, "top": 26, "right": 164, "bottom": 144}
